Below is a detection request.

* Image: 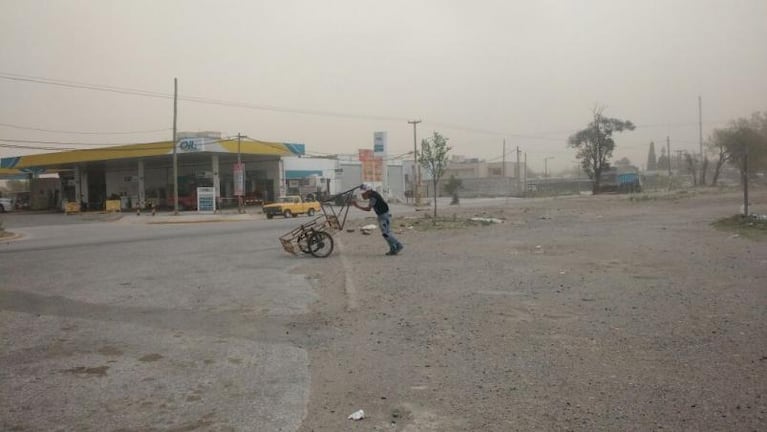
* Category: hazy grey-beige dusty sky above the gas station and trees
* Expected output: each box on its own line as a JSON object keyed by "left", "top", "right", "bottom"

{"left": 0, "top": 0, "right": 767, "bottom": 170}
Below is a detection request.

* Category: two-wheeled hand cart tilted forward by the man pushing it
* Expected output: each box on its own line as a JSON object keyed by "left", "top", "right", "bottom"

{"left": 280, "top": 186, "right": 360, "bottom": 258}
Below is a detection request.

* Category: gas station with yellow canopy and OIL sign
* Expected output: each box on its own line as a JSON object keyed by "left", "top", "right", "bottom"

{"left": 0, "top": 132, "right": 305, "bottom": 211}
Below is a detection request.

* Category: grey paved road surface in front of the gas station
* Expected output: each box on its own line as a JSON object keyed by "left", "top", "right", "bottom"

{"left": 0, "top": 214, "right": 317, "bottom": 431}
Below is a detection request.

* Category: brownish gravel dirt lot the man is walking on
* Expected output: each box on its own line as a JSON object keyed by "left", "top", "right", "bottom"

{"left": 291, "top": 189, "right": 767, "bottom": 432}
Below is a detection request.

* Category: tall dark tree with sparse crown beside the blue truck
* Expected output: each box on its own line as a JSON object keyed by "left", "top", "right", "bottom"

{"left": 568, "top": 107, "right": 634, "bottom": 194}
